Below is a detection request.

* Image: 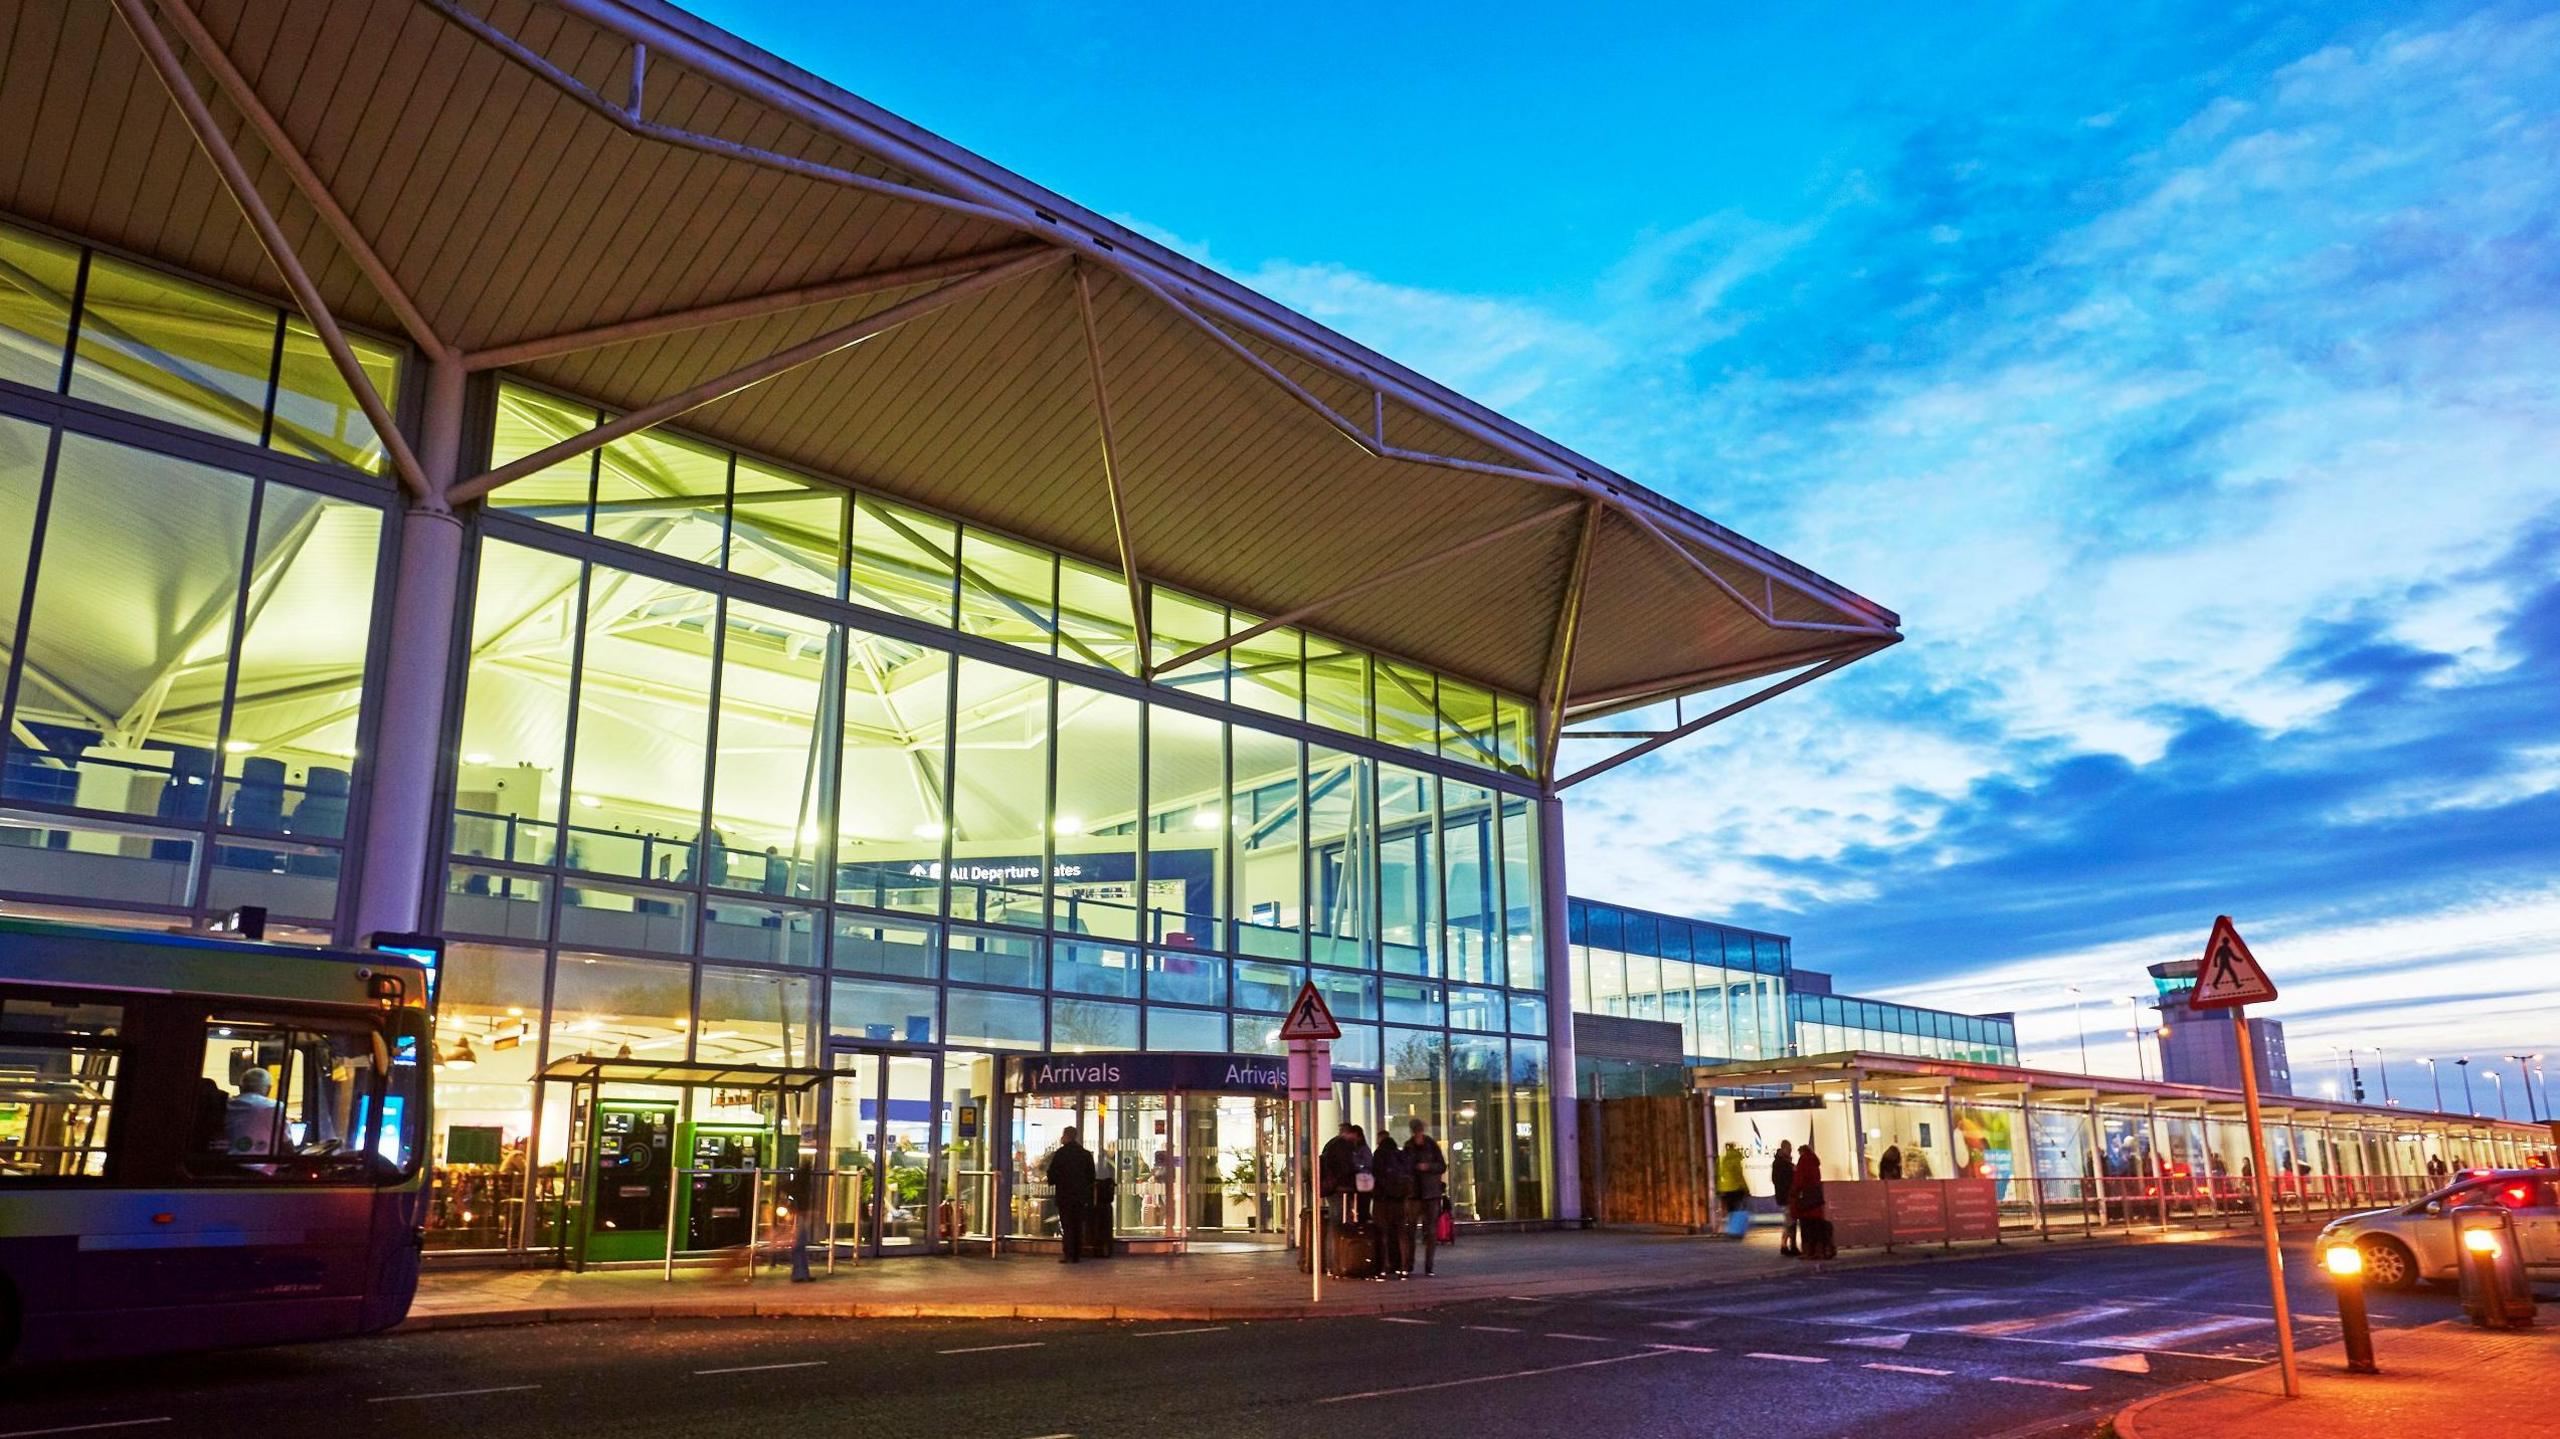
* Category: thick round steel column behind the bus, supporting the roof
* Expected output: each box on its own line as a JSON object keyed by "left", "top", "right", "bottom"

{"left": 356, "top": 358, "right": 463, "bottom": 937}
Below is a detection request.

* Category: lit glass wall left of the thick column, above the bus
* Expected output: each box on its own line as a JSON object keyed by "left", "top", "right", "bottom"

{"left": 0, "top": 215, "right": 399, "bottom": 940}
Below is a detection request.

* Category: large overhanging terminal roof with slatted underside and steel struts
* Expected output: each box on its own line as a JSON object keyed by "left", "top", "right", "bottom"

{"left": 0, "top": 0, "right": 1900, "bottom": 781}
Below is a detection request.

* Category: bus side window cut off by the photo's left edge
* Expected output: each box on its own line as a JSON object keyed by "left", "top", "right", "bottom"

{"left": 0, "top": 991, "right": 123, "bottom": 1183}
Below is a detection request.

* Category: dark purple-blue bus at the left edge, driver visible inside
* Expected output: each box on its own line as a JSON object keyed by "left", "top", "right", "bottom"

{"left": 0, "top": 917, "right": 435, "bottom": 1365}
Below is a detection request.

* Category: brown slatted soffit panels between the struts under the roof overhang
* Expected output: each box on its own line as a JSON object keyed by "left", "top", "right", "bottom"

{"left": 0, "top": 0, "right": 1897, "bottom": 722}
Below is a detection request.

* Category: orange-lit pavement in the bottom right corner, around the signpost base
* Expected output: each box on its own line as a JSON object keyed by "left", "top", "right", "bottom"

{"left": 2115, "top": 1321, "right": 2560, "bottom": 1439}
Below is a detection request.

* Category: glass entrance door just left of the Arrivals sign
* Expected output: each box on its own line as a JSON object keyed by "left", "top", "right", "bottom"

{"left": 827, "top": 1050, "right": 940, "bottom": 1255}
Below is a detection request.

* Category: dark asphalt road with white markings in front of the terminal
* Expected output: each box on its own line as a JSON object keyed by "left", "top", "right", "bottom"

{"left": 0, "top": 1242, "right": 2498, "bottom": 1439}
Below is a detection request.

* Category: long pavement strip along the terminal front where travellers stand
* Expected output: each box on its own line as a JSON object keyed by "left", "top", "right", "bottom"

{"left": 402, "top": 1213, "right": 2209, "bottom": 1331}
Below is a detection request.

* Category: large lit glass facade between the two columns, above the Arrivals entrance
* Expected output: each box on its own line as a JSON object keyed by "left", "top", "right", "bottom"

{"left": 440, "top": 389, "right": 1551, "bottom": 1244}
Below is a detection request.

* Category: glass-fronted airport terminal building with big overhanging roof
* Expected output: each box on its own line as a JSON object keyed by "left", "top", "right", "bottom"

{"left": 0, "top": 0, "right": 1900, "bottom": 1252}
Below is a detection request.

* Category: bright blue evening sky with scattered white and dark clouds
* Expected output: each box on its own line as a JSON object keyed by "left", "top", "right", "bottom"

{"left": 701, "top": 0, "right": 2560, "bottom": 1114}
